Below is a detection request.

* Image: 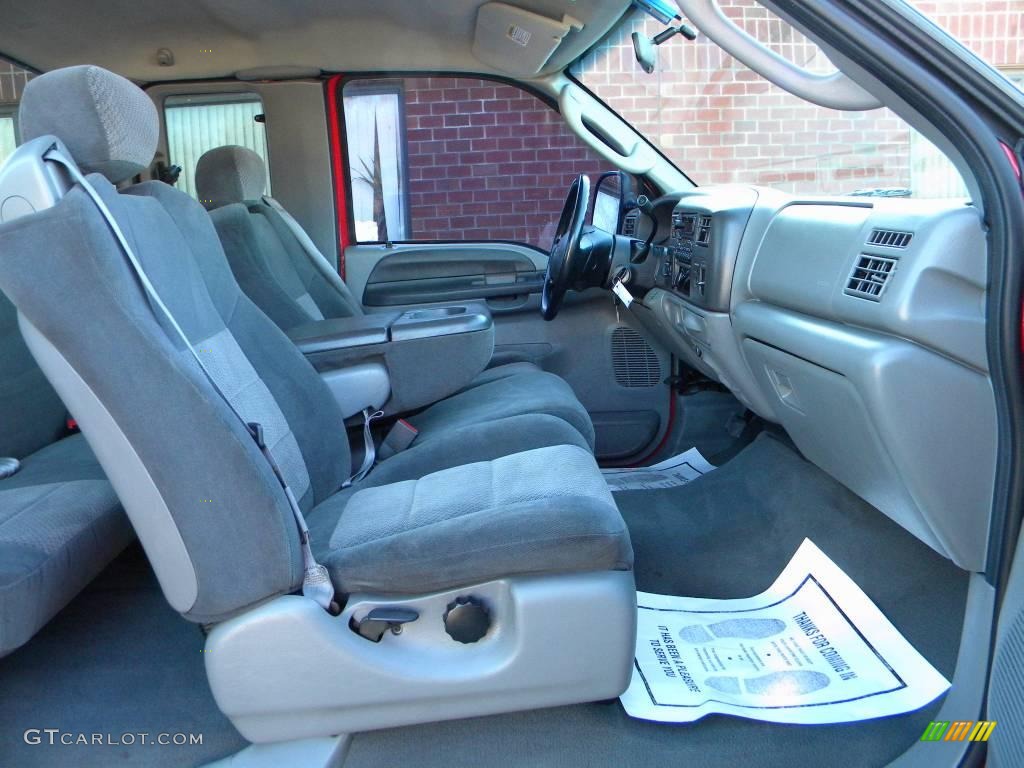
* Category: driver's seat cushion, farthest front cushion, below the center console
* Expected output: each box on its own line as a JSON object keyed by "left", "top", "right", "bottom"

{"left": 407, "top": 364, "right": 594, "bottom": 451}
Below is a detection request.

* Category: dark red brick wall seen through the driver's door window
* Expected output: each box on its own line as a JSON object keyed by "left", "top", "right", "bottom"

{"left": 403, "top": 78, "right": 609, "bottom": 247}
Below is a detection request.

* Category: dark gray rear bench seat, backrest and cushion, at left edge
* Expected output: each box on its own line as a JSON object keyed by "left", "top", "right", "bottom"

{"left": 0, "top": 294, "right": 133, "bottom": 656}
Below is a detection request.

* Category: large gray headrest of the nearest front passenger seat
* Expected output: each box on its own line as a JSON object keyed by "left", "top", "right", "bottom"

{"left": 18, "top": 65, "right": 160, "bottom": 183}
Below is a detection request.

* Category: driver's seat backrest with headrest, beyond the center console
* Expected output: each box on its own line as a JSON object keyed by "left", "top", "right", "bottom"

{"left": 196, "top": 145, "right": 362, "bottom": 331}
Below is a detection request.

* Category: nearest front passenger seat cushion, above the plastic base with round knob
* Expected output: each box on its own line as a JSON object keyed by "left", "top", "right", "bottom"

{"left": 312, "top": 445, "right": 633, "bottom": 594}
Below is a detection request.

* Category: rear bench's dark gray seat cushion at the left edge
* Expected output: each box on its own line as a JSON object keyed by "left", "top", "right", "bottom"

{"left": 0, "top": 435, "right": 132, "bottom": 655}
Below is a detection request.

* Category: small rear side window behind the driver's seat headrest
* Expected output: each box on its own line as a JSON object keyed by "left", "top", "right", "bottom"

{"left": 164, "top": 93, "right": 270, "bottom": 198}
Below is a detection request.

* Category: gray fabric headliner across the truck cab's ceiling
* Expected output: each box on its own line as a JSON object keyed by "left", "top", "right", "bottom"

{"left": 0, "top": 0, "right": 630, "bottom": 83}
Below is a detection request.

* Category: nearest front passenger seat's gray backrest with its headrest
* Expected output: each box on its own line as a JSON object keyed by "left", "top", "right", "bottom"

{"left": 0, "top": 67, "right": 350, "bottom": 622}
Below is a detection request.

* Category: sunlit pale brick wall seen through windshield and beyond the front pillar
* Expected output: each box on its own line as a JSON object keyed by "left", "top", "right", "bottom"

{"left": 570, "top": 0, "right": 1024, "bottom": 198}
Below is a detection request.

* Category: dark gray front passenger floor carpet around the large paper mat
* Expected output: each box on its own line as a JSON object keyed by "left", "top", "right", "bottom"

{"left": 345, "top": 436, "right": 968, "bottom": 768}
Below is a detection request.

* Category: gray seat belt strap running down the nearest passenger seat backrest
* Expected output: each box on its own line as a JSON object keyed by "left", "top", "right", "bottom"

{"left": 43, "top": 147, "right": 334, "bottom": 609}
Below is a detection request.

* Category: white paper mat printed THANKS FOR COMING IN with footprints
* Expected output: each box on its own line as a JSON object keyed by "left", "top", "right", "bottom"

{"left": 622, "top": 539, "right": 949, "bottom": 724}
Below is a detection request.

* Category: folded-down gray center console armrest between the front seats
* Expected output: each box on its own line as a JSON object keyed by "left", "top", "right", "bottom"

{"left": 288, "top": 304, "right": 495, "bottom": 418}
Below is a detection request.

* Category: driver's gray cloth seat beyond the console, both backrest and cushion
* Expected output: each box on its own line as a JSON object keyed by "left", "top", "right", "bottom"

{"left": 196, "top": 145, "right": 594, "bottom": 450}
